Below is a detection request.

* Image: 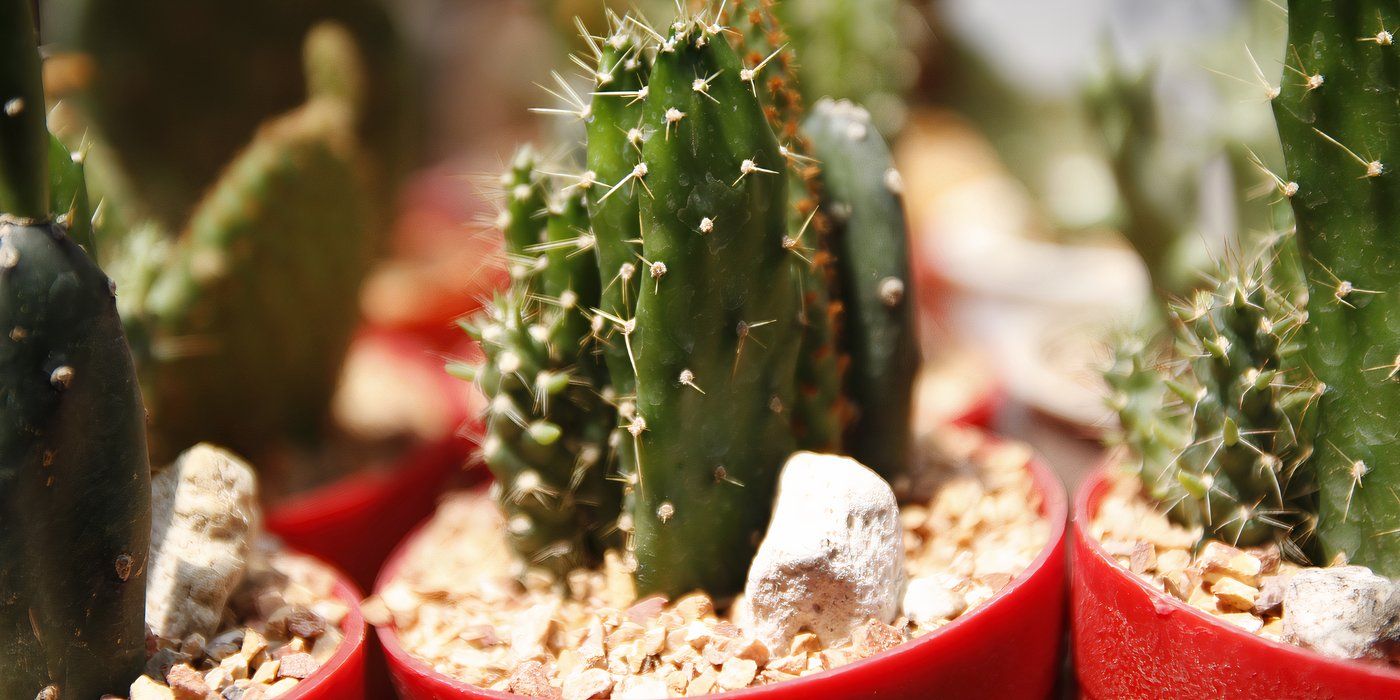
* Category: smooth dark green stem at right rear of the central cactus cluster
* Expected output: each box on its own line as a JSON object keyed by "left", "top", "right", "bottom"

{"left": 805, "top": 101, "right": 920, "bottom": 483}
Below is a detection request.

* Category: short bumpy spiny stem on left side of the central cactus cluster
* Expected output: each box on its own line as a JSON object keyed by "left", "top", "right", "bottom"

{"left": 449, "top": 148, "right": 620, "bottom": 574}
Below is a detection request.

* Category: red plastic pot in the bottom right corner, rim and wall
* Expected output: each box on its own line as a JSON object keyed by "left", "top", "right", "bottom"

{"left": 1071, "top": 468, "right": 1400, "bottom": 700}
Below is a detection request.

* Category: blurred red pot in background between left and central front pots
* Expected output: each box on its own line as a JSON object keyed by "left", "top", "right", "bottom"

{"left": 267, "top": 324, "right": 480, "bottom": 588}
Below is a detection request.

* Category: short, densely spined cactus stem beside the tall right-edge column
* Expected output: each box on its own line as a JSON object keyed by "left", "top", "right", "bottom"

{"left": 1109, "top": 242, "right": 1316, "bottom": 557}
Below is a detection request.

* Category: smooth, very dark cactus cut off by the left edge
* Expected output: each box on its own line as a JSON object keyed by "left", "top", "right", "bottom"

{"left": 0, "top": 0, "right": 151, "bottom": 697}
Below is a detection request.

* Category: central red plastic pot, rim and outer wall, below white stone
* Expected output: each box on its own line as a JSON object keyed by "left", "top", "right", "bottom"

{"left": 375, "top": 450, "right": 1068, "bottom": 700}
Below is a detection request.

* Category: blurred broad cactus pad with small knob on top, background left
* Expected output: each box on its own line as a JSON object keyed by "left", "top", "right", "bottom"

{"left": 93, "top": 24, "right": 384, "bottom": 470}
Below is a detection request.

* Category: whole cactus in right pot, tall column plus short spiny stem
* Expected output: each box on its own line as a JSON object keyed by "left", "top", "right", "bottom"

{"left": 1114, "top": 0, "right": 1400, "bottom": 577}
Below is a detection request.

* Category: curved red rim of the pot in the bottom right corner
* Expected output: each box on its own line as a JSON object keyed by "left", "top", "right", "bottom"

{"left": 1072, "top": 456, "right": 1400, "bottom": 682}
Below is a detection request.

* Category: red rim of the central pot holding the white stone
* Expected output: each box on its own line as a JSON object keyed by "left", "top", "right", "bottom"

{"left": 374, "top": 455, "right": 1070, "bottom": 700}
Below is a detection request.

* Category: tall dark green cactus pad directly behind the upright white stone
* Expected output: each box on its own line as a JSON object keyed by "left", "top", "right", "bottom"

{"left": 630, "top": 20, "right": 801, "bottom": 596}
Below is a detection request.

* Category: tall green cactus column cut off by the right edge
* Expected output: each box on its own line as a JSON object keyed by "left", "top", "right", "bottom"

{"left": 1274, "top": 0, "right": 1400, "bottom": 577}
